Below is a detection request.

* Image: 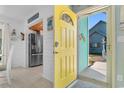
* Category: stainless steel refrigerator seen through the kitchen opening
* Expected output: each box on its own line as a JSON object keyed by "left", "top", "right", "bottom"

{"left": 28, "top": 33, "right": 43, "bottom": 67}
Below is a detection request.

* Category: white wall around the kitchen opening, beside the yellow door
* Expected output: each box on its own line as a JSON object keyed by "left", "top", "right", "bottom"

{"left": 25, "top": 5, "right": 54, "bottom": 81}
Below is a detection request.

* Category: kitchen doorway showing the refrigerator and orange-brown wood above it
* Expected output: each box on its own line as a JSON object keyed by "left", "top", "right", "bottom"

{"left": 28, "top": 21, "right": 43, "bottom": 73}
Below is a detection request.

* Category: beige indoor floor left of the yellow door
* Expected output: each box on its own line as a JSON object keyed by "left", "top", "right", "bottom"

{"left": 0, "top": 66, "right": 53, "bottom": 88}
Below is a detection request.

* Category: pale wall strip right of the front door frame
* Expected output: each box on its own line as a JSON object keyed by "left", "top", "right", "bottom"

{"left": 116, "top": 6, "right": 124, "bottom": 87}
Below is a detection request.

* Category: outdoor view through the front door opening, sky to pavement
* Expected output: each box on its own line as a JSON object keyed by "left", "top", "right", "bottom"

{"left": 87, "top": 12, "right": 107, "bottom": 82}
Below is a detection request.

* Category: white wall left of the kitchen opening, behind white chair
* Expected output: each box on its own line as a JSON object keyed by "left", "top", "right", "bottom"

{"left": 0, "top": 15, "right": 25, "bottom": 67}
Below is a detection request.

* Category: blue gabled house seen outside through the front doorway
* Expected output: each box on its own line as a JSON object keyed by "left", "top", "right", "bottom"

{"left": 89, "top": 21, "right": 106, "bottom": 54}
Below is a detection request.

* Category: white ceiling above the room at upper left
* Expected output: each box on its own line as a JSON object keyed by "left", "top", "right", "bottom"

{"left": 0, "top": 5, "right": 39, "bottom": 21}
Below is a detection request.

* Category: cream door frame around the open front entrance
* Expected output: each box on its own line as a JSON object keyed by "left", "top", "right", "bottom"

{"left": 77, "top": 5, "right": 116, "bottom": 87}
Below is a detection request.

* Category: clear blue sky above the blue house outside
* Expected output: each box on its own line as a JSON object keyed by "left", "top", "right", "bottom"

{"left": 88, "top": 13, "right": 106, "bottom": 29}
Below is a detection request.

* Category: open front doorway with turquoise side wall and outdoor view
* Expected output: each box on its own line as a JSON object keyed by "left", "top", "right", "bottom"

{"left": 78, "top": 8, "right": 112, "bottom": 86}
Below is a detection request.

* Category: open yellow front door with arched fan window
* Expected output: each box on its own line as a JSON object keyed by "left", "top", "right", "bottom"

{"left": 54, "top": 5, "right": 77, "bottom": 87}
